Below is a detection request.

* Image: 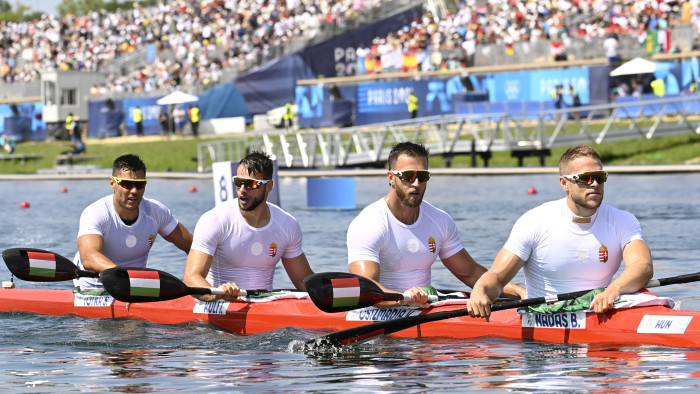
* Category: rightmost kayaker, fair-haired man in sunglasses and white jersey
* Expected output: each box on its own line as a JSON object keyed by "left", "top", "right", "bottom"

{"left": 467, "top": 145, "right": 654, "bottom": 318}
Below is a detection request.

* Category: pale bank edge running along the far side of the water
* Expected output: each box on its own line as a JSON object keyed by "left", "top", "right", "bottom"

{"left": 0, "top": 164, "right": 700, "bottom": 181}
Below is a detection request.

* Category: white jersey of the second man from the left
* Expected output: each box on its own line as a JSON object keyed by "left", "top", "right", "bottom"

{"left": 192, "top": 199, "right": 303, "bottom": 290}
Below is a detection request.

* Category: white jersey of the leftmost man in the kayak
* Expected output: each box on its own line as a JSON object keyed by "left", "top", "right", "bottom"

{"left": 74, "top": 195, "right": 178, "bottom": 290}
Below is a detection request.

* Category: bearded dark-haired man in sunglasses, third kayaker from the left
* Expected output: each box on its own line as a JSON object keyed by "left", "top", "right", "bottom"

{"left": 347, "top": 142, "right": 525, "bottom": 308}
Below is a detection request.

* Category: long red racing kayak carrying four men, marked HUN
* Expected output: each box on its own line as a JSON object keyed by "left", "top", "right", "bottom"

{"left": 0, "top": 288, "right": 700, "bottom": 348}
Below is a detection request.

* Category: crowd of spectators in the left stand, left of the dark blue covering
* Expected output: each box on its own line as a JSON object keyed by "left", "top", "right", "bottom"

{"left": 0, "top": 0, "right": 379, "bottom": 94}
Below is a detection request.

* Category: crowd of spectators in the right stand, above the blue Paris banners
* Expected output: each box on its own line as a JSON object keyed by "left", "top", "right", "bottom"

{"left": 357, "top": 0, "right": 700, "bottom": 73}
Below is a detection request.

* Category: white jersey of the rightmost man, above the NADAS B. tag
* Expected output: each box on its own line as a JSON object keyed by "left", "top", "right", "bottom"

{"left": 504, "top": 198, "right": 642, "bottom": 297}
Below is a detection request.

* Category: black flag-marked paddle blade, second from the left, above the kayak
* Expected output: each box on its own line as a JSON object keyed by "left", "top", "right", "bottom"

{"left": 100, "top": 267, "right": 190, "bottom": 302}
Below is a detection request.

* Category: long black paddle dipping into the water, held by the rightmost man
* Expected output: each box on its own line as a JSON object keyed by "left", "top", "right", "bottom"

{"left": 304, "top": 272, "right": 700, "bottom": 350}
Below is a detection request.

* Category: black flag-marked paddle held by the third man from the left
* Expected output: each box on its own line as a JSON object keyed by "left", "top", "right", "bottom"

{"left": 304, "top": 272, "right": 469, "bottom": 313}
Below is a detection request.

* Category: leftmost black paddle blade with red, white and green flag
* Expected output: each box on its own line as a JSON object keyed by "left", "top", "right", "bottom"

{"left": 2, "top": 248, "right": 97, "bottom": 282}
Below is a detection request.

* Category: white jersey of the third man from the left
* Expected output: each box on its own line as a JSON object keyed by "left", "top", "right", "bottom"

{"left": 347, "top": 198, "right": 464, "bottom": 292}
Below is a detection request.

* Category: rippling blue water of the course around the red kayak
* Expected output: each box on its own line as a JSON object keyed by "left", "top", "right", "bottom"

{"left": 0, "top": 174, "right": 700, "bottom": 393}
